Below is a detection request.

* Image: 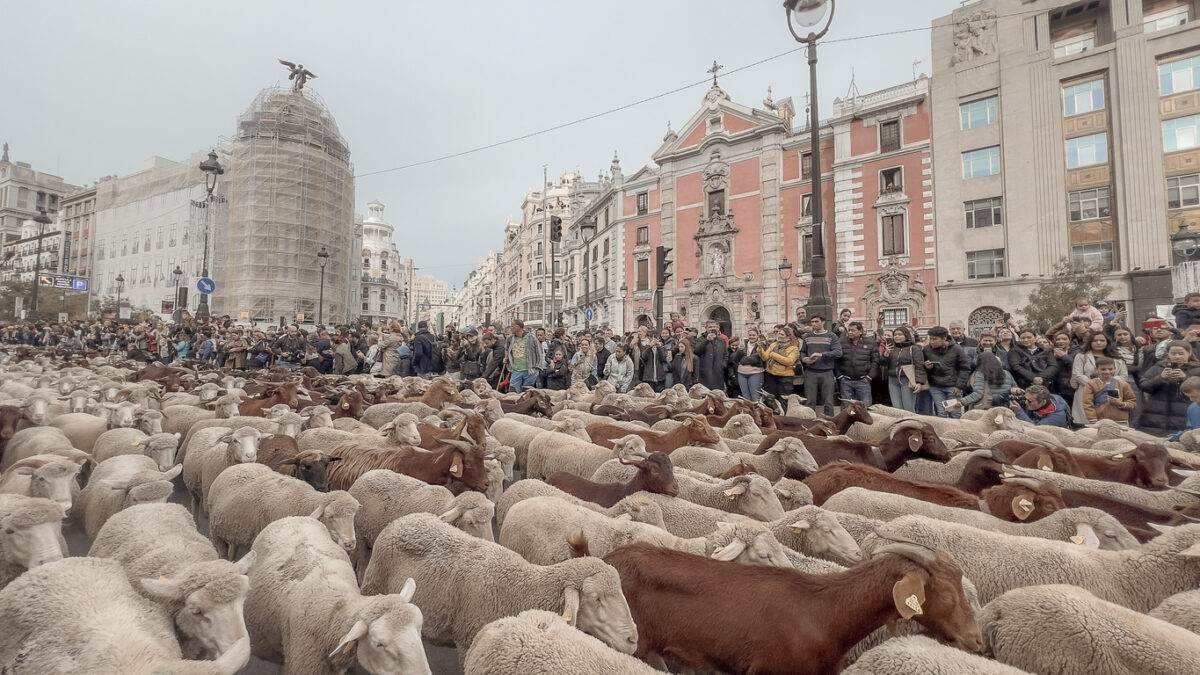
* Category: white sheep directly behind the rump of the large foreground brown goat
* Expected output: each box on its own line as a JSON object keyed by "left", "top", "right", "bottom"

{"left": 500, "top": 497, "right": 791, "bottom": 567}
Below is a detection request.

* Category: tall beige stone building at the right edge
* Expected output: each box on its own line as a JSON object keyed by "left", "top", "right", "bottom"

{"left": 931, "top": 0, "right": 1200, "bottom": 331}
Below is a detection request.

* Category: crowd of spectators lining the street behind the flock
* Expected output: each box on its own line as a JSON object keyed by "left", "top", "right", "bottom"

{"left": 7, "top": 293, "right": 1200, "bottom": 436}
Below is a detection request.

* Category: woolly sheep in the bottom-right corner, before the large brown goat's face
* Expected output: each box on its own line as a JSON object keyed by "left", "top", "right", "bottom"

{"left": 979, "top": 584, "right": 1200, "bottom": 675}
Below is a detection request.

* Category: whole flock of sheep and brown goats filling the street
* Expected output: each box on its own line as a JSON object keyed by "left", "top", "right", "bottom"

{"left": 0, "top": 352, "right": 1200, "bottom": 675}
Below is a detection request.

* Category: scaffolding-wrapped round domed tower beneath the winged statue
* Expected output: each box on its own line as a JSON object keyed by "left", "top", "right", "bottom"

{"left": 212, "top": 86, "right": 354, "bottom": 323}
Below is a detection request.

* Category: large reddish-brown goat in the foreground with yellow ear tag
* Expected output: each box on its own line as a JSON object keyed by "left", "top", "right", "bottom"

{"left": 604, "top": 543, "right": 983, "bottom": 675}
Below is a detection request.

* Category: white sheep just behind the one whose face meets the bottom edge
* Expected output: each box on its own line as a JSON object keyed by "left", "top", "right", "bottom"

{"left": 208, "top": 462, "right": 359, "bottom": 560}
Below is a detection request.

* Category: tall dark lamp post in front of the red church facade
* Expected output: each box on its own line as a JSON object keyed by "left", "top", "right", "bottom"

{"left": 784, "top": 0, "right": 834, "bottom": 321}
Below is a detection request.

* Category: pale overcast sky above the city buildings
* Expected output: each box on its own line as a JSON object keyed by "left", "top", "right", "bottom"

{"left": 0, "top": 0, "right": 960, "bottom": 285}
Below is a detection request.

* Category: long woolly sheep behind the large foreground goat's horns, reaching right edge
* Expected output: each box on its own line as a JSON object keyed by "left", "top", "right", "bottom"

{"left": 881, "top": 515, "right": 1200, "bottom": 611}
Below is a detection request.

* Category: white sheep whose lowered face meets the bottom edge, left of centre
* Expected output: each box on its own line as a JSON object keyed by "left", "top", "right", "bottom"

{"left": 246, "top": 516, "right": 431, "bottom": 675}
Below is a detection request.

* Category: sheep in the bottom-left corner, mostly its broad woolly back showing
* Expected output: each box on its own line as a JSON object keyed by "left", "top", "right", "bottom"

{"left": 0, "top": 557, "right": 250, "bottom": 675}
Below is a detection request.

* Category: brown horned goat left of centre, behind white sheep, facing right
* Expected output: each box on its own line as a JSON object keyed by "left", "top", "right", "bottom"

{"left": 326, "top": 438, "right": 487, "bottom": 492}
